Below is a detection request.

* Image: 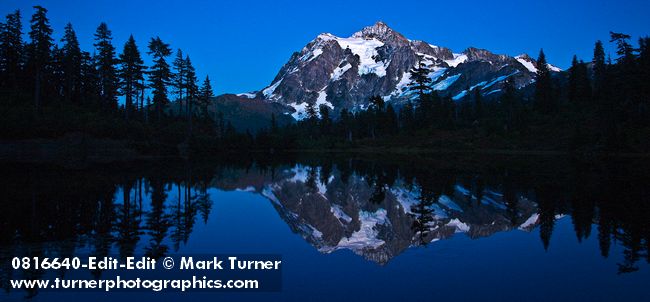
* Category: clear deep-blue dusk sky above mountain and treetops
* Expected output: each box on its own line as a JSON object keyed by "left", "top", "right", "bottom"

{"left": 0, "top": 0, "right": 650, "bottom": 94}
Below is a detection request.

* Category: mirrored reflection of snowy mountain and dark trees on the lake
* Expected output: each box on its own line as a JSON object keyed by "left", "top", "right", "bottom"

{"left": 0, "top": 157, "right": 650, "bottom": 298}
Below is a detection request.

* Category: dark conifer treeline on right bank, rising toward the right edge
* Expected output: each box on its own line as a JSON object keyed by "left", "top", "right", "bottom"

{"left": 257, "top": 33, "right": 650, "bottom": 152}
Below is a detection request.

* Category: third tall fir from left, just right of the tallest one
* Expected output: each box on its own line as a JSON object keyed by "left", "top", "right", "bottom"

{"left": 61, "top": 23, "right": 81, "bottom": 104}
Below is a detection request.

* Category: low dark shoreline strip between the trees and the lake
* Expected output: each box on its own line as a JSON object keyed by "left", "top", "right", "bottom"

{"left": 0, "top": 134, "right": 650, "bottom": 165}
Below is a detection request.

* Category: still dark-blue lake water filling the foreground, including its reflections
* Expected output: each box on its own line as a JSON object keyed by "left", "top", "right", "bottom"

{"left": 0, "top": 155, "right": 650, "bottom": 301}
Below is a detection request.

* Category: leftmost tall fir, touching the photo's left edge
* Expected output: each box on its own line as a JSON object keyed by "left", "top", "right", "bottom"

{"left": 0, "top": 10, "right": 25, "bottom": 93}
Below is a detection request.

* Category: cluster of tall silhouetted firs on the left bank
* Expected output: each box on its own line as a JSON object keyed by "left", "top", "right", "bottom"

{"left": 0, "top": 6, "right": 224, "bottom": 149}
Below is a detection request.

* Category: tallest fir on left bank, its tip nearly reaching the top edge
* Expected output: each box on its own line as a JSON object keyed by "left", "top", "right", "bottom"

{"left": 27, "top": 5, "right": 53, "bottom": 117}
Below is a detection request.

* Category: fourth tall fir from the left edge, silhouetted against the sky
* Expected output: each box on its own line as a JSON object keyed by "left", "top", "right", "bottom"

{"left": 93, "top": 22, "right": 118, "bottom": 111}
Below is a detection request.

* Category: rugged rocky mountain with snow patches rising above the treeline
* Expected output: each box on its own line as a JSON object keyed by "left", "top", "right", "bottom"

{"left": 238, "top": 22, "right": 560, "bottom": 119}
